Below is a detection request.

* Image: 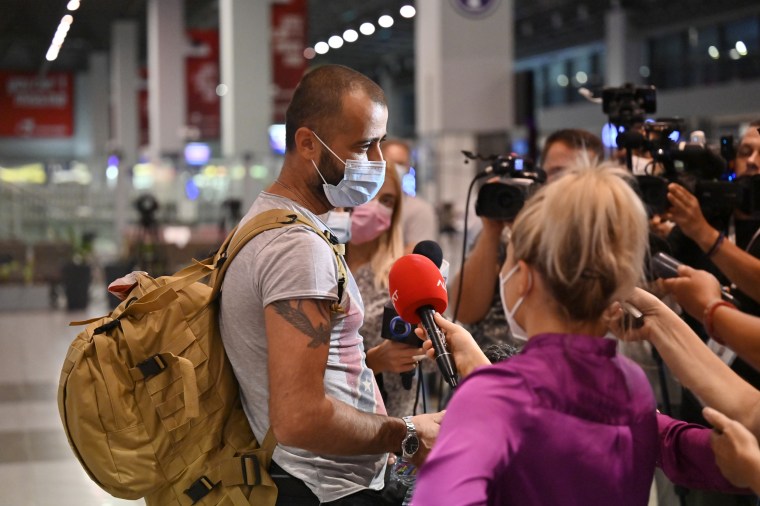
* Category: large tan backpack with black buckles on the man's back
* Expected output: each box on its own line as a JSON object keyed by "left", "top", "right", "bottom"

{"left": 58, "top": 209, "right": 346, "bottom": 506}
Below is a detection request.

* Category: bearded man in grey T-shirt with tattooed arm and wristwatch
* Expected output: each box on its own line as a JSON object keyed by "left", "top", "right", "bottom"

{"left": 220, "top": 65, "right": 441, "bottom": 505}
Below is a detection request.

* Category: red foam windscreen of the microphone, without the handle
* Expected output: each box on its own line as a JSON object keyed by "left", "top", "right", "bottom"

{"left": 388, "top": 253, "right": 449, "bottom": 325}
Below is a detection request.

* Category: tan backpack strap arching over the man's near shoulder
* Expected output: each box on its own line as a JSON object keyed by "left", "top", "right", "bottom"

{"left": 210, "top": 209, "right": 348, "bottom": 302}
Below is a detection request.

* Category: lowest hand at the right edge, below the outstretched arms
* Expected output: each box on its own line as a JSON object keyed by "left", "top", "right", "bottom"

{"left": 702, "top": 408, "right": 760, "bottom": 492}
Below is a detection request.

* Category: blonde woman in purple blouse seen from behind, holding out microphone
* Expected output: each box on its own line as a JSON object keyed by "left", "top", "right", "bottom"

{"left": 413, "top": 166, "right": 744, "bottom": 506}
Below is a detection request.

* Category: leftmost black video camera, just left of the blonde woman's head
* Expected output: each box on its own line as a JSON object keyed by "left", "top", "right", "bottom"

{"left": 462, "top": 151, "right": 546, "bottom": 221}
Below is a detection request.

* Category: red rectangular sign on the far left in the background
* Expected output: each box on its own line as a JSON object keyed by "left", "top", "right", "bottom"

{"left": 0, "top": 71, "right": 74, "bottom": 137}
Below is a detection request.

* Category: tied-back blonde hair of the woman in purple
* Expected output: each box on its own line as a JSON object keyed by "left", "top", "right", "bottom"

{"left": 511, "top": 163, "right": 649, "bottom": 321}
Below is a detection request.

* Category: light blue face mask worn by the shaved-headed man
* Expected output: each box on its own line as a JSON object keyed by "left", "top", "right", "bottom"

{"left": 311, "top": 131, "right": 385, "bottom": 207}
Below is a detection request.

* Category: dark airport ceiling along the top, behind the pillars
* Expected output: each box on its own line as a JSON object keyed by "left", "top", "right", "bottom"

{"left": 0, "top": 0, "right": 758, "bottom": 78}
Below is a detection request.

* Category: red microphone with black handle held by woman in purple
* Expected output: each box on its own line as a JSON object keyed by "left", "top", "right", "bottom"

{"left": 388, "top": 253, "right": 458, "bottom": 387}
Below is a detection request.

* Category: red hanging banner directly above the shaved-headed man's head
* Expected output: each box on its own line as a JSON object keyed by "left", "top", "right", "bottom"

{"left": 272, "top": 0, "right": 306, "bottom": 123}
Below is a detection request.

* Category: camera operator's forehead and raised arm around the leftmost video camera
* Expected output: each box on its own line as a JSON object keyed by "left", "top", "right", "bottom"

{"left": 449, "top": 129, "right": 604, "bottom": 348}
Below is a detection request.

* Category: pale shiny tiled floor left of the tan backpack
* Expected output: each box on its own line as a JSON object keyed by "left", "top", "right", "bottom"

{"left": 0, "top": 290, "right": 145, "bottom": 506}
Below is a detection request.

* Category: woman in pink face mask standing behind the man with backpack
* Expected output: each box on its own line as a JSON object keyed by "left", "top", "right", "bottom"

{"left": 346, "top": 162, "right": 424, "bottom": 416}
